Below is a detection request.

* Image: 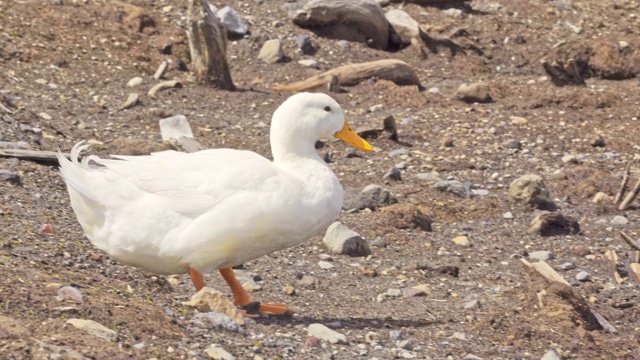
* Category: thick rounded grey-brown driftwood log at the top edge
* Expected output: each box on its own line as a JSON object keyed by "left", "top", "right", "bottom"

{"left": 292, "top": 0, "right": 389, "bottom": 50}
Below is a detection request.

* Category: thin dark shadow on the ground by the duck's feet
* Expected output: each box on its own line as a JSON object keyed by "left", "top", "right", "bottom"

{"left": 255, "top": 316, "right": 442, "bottom": 329}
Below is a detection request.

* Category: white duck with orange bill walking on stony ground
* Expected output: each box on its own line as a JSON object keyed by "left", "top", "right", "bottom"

{"left": 58, "top": 93, "right": 372, "bottom": 314}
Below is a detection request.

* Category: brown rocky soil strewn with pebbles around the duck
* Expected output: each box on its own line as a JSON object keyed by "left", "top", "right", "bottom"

{"left": 0, "top": 0, "right": 640, "bottom": 359}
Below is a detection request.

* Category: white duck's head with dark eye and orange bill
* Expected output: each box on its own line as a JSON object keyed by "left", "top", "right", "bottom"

{"left": 271, "top": 93, "right": 373, "bottom": 156}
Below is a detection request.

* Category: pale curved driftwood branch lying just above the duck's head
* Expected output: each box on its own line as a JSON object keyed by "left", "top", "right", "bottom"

{"left": 273, "top": 59, "right": 422, "bottom": 92}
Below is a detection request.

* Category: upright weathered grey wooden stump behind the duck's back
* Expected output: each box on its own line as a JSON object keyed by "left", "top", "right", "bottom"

{"left": 187, "top": 0, "right": 236, "bottom": 90}
